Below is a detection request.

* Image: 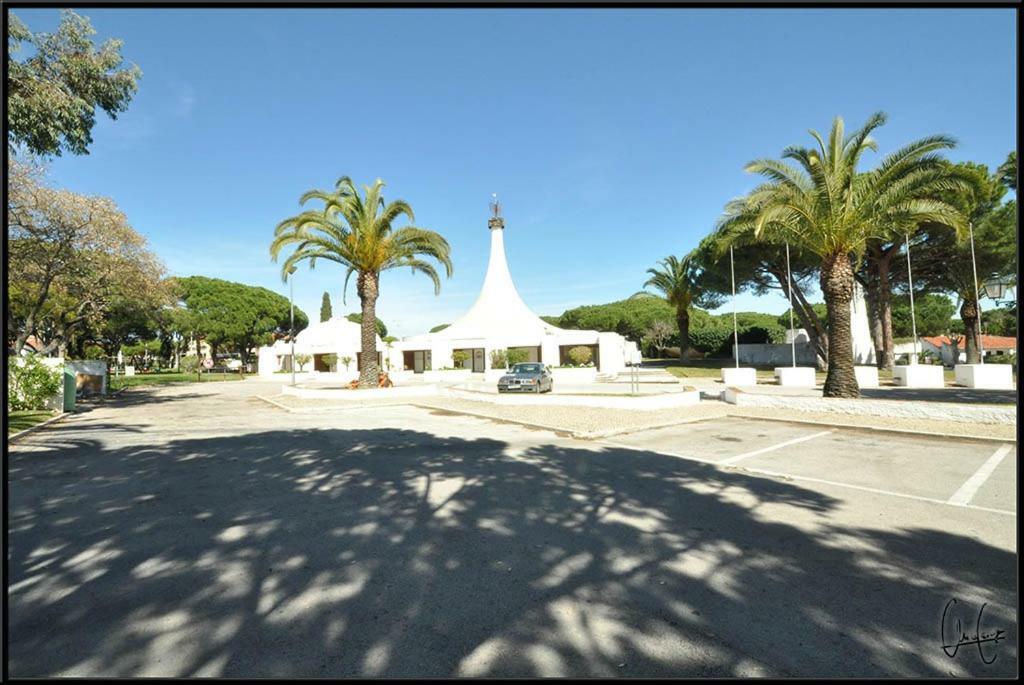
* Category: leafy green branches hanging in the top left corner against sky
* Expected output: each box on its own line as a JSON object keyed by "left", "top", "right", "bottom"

{"left": 7, "top": 9, "right": 142, "bottom": 156}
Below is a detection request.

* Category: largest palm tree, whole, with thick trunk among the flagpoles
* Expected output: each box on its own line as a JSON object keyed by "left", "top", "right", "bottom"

{"left": 746, "top": 112, "right": 966, "bottom": 397}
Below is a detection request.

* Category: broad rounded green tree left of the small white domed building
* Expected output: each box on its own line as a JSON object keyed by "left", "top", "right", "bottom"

{"left": 175, "top": 275, "right": 309, "bottom": 363}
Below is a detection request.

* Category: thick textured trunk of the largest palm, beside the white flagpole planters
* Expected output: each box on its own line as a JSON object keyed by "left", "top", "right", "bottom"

{"left": 821, "top": 252, "right": 860, "bottom": 397}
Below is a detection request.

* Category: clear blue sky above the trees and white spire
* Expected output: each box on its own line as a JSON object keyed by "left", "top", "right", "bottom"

{"left": 15, "top": 8, "right": 1017, "bottom": 335}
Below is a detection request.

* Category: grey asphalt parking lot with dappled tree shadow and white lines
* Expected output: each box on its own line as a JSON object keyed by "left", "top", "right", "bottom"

{"left": 7, "top": 381, "right": 1017, "bottom": 677}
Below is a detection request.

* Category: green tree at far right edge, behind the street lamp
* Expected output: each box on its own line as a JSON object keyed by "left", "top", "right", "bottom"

{"left": 910, "top": 162, "right": 1017, "bottom": 363}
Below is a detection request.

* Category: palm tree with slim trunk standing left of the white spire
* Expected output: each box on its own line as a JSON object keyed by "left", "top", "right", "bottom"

{"left": 270, "top": 176, "right": 452, "bottom": 388}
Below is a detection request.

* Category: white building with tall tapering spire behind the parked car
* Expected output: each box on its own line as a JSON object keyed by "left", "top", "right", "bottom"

{"left": 394, "top": 204, "right": 640, "bottom": 375}
